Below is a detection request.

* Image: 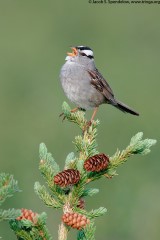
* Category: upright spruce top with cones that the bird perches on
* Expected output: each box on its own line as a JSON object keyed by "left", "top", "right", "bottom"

{"left": 35, "top": 102, "right": 156, "bottom": 240}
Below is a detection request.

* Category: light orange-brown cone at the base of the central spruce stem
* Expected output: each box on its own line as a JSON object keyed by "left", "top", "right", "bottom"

{"left": 62, "top": 212, "right": 90, "bottom": 230}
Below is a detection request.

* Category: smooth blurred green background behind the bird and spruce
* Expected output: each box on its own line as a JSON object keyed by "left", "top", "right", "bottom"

{"left": 0, "top": 0, "right": 160, "bottom": 240}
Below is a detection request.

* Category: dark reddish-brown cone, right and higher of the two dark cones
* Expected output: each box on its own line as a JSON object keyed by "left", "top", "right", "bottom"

{"left": 84, "top": 153, "right": 109, "bottom": 172}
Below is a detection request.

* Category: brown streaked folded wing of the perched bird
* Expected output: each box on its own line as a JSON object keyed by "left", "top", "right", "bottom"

{"left": 88, "top": 69, "right": 116, "bottom": 104}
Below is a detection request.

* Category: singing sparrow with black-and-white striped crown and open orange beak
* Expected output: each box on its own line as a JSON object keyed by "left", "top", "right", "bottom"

{"left": 60, "top": 46, "right": 139, "bottom": 122}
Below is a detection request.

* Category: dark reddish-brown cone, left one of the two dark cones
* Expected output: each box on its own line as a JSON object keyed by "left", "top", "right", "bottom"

{"left": 54, "top": 169, "right": 80, "bottom": 187}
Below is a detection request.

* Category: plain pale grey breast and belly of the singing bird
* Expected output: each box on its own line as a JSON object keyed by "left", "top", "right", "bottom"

{"left": 60, "top": 61, "right": 104, "bottom": 109}
